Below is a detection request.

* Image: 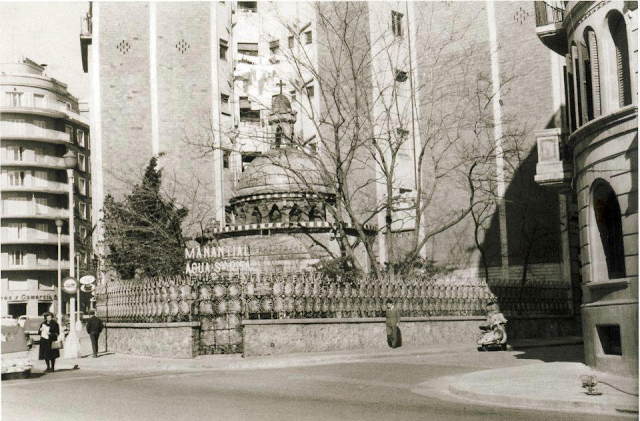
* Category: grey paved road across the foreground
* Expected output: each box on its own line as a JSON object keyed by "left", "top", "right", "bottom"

{"left": 2, "top": 349, "right": 624, "bottom": 421}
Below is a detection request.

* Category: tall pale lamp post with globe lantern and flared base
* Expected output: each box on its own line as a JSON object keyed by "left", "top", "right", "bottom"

{"left": 62, "top": 150, "right": 80, "bottom": 359}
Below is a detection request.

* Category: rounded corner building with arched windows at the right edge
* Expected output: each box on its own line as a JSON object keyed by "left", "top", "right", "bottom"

{"left": 535, "top": 1, "right": 638, "bottom": 375}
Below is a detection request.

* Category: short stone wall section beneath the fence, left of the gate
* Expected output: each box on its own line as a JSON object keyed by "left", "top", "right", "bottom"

{"left": 99, "top": 322, "right": 200, "bottom": 358}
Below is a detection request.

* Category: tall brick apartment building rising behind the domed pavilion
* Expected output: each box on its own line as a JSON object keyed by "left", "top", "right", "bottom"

{"left": 81, "top": 1, "right": 580, "bottom": 292}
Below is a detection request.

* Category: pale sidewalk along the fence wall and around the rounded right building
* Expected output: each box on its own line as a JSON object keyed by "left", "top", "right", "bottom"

{"left": 28, "top": 336, "right": 638, "bottom": 418}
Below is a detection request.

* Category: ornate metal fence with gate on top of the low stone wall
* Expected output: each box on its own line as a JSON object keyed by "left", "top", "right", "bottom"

{"left": 96, "top": 272, "right": 572, "bottom": 355}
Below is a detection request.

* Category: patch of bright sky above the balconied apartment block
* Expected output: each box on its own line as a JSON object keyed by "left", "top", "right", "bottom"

{"left": 0, "top": 1, "right": 91, "bottom": 100}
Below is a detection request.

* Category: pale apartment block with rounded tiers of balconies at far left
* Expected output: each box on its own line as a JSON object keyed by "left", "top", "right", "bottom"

{"left": 0, "top": 59, "right": 92, "bottom": 318}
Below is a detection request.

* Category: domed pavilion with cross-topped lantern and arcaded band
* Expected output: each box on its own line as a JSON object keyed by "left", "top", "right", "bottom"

{"left": 205, "top": 94, "right": 373, "bottom": 270}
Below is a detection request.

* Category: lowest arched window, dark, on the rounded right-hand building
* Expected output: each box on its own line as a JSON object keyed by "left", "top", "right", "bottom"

{"left": 593, "top": 181, "right": 626, "bottom": 279}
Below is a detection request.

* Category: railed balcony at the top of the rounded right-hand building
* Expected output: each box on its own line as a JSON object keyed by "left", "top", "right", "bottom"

{"left": 534, "top": 1, "right": 567, "bottom": 56}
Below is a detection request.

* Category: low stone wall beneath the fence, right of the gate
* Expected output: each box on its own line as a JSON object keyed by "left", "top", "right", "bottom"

{"left": 243, "top": 316, "right": 580, "bottom": 357}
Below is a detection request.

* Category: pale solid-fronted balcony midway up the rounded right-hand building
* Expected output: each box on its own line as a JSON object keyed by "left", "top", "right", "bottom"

{"left": 535, "top": 129, "right": 573, "bottom": 190}
